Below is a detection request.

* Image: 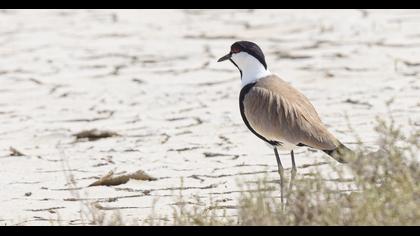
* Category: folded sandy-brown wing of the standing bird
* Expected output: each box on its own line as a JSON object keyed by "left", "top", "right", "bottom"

{"left": 243, "top": 75, "right": 338, "bottom": 150}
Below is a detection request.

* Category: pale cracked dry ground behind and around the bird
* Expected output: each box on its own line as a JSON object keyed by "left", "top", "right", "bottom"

{"left": 0, "top": 10, "right": 420, "bottom": 225}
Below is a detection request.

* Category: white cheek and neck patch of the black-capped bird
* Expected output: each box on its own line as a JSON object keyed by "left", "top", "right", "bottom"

{"left": 231, "top": 52, "right": 271, "bottom": 87}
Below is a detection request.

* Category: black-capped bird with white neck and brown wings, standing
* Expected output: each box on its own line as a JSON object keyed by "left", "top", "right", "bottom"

{"left": 218, "top": 41, "right": 354, "bottom": 203}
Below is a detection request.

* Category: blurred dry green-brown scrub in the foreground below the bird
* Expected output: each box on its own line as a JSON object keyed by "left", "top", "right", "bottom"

{"left": 60, "top": 115, "right": 420, "bottom": 225}
